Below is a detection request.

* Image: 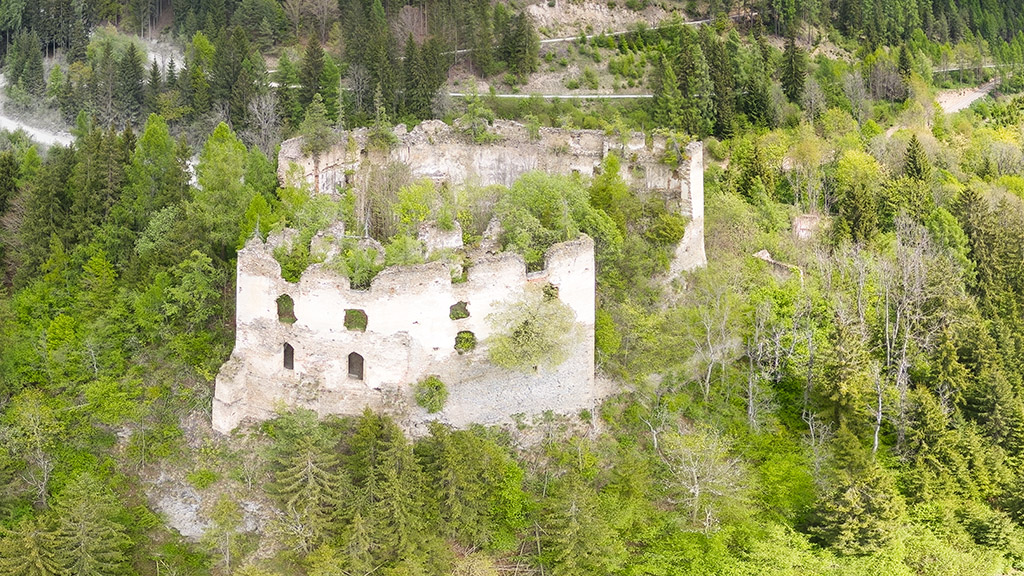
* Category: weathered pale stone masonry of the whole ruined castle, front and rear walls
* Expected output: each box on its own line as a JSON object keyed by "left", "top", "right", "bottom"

{"left": 213, "top": 122, "right": 705, "bottom": 433}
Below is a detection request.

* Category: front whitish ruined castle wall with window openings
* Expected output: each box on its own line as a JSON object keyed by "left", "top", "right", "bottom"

{"left": 213, "top": 231, "right": 597, "bottom": 433}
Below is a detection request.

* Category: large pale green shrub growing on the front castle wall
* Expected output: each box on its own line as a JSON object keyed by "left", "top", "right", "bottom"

{"left": 487, "top": 287, "right": 577, "bottom": 370}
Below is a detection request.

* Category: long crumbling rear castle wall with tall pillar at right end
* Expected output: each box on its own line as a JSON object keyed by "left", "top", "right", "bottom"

{"left": 278, "top": 120, "right": 707, "bottom": 274}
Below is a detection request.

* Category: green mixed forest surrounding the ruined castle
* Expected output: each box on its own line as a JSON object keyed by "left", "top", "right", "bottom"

{"left": 0, "top": 0, "right": 1024, "bottom": 576}
